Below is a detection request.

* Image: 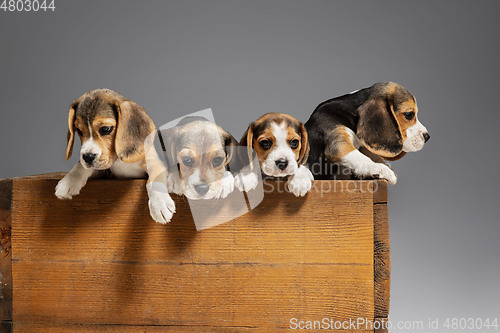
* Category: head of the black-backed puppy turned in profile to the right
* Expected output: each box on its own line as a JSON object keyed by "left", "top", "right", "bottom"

{"left": 356, "top": 82, "right": 430, "bottom": 160}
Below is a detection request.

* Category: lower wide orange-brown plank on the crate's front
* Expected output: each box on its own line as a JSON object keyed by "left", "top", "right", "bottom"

{"left": 13, "top": 261, "right": 373, "bottom": 328}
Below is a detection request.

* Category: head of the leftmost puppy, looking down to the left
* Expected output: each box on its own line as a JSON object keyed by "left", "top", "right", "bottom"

{"left": 66, "top": 89, "right": 154, "bottom": 170}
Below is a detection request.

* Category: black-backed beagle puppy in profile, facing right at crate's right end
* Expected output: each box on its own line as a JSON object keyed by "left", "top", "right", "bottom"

{"left": 305, "top": 82, "right": 430, "bottom": 184}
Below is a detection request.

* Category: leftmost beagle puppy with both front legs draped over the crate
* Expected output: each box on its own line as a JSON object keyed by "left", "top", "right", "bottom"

{"left": 55, "top": 89, "right": 175, "bottom": 224}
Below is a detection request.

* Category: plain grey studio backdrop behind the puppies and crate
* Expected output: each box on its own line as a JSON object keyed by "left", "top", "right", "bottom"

{"left": 0, "top": 0, "right": 500, "bottom": 322}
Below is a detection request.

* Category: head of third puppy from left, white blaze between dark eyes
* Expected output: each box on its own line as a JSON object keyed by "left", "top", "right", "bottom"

{"left": 240, "top": 113, "right": 309, "bottom": 177}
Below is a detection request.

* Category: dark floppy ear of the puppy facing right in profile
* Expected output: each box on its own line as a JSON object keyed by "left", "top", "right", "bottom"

{"left": 356, "top": 97, "right": 403, "bottom": 157}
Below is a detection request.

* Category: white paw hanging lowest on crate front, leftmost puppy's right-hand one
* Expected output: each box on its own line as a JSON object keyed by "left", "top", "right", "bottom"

{"left": 147, "top": 182, "right": 175, "bottom": 224}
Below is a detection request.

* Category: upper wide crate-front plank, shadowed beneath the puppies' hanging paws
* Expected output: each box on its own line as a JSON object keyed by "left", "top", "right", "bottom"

{"left": 13, "top": 179, "right": 373, "bottom": 265}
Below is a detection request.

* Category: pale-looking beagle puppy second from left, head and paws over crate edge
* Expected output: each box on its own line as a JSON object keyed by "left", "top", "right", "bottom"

{"left": 160, "top": 116, "right": 238, "bottom": 200}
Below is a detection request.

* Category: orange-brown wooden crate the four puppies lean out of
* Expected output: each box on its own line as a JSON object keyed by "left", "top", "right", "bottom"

{"left": 0, "top": 174, "right": 390, "bottom": 332}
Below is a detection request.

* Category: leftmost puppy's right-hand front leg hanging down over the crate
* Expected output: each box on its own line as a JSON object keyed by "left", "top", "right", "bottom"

{"left": 146, "top": 151, "right": 175, "bottom": 224}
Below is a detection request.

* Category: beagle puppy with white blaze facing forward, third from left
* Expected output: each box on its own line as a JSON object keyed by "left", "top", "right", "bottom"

{"left": 235, "top": 113, "right": 313, "bottom": 196}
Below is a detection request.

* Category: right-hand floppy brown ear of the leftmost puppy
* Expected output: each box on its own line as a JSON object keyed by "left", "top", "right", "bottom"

{"left": 114, "top": 100, "right": 155, "bottom": 163}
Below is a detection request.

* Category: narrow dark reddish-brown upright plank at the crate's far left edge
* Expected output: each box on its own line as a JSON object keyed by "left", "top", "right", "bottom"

{"left": 0, "top": 179, "right": 12, "bottom": 332}
